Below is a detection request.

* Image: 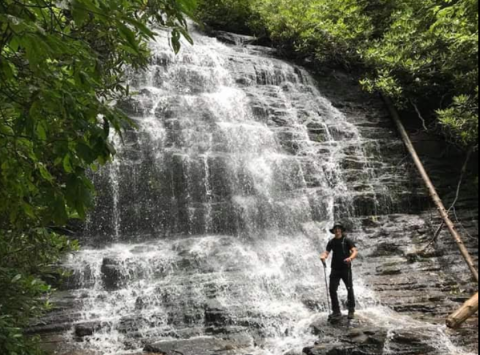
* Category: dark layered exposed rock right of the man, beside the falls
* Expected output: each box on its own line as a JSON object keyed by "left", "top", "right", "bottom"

{"left": 318, "top": 72, "right": 478, "bottom": 354}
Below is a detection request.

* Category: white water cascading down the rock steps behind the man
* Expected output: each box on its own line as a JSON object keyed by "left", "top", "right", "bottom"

{"left": 49, "top": 26, "right": 476, "bottom": 355}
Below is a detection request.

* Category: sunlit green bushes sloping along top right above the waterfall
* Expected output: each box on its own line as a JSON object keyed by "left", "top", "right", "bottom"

{"left": 199, "top": 0, "right": 478, "bottom": 149}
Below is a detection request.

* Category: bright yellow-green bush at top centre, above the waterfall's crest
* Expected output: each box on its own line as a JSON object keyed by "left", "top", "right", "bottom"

{"left": 254, "top": 0, "right": 373, "bottom": 64}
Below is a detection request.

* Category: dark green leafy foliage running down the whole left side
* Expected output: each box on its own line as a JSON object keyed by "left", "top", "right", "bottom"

{"left": 0, "top": 0, "right": 196, "bottom": 355}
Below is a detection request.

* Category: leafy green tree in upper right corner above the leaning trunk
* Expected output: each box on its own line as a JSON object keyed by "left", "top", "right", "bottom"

{"left": 359, "top": 0, "right": 478, "bottom": 150}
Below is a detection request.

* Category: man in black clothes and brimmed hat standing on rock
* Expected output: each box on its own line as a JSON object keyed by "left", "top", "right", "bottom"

{"left": 321, "top": 224, "right": 358, "bottom": 321}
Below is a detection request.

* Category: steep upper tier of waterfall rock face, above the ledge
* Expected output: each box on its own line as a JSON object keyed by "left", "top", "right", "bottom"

{"left": 81, "top": 28, "right": 421, "bottom": 244}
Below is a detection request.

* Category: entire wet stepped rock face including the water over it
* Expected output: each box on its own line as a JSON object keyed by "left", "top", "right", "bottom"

{"left": 36, "top": 29, "right": 478, "bottom": 355}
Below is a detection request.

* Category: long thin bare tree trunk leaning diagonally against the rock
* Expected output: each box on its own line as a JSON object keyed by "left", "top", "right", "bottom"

{"left": 384, "top": 97, "right": 478, "bottom": 283}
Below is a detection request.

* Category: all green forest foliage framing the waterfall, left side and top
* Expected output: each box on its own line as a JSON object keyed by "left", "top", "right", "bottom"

{"left": 0, "top": 0, "right": 478, "bottom": 355}
